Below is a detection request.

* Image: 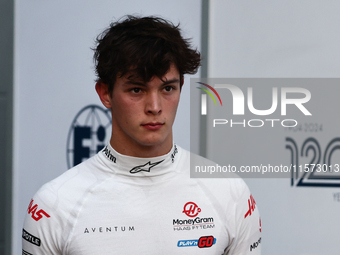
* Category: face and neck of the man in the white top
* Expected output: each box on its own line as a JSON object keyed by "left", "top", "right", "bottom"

{"left": 110, "top": 65, "right": 181, "bottom": 156}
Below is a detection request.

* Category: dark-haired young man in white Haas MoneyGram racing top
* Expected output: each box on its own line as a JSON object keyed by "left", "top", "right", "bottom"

{"left": 23, "top": 16, "right": 261, "bottom": 255}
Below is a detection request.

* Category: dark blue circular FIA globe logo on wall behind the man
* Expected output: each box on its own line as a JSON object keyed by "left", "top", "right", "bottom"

{"left": 66, "top": 105, "right": 112, "bottom": 168}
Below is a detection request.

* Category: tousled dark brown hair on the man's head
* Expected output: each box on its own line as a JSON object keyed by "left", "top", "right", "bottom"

{"left": 93, "top": 15, "right": 201, "bottom": 93}
